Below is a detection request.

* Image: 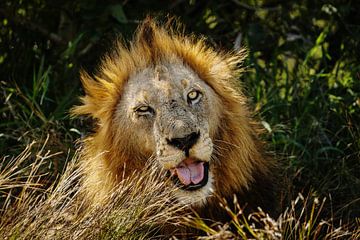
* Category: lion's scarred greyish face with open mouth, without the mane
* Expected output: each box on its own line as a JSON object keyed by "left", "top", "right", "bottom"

{"left": 115, "top": 63, "right": 220, "bottom": 204}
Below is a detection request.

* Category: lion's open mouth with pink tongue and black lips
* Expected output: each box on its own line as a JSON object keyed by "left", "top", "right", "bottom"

{"left": 170, "top": 158, "right": 209, "bottom": 191}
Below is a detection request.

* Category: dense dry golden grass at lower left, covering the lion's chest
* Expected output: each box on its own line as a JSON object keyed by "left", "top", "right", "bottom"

{"left": 0, "top": 140, "right": 184, "bottom": 239}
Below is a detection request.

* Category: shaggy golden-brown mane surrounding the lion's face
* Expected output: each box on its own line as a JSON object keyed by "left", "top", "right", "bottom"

{"left": 72, "top": 18, "right": 272, "bottom": 214}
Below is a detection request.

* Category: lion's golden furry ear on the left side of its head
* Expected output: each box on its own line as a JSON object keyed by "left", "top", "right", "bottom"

{"left": 70, "top": 71, "right": 115, "bottom": 120}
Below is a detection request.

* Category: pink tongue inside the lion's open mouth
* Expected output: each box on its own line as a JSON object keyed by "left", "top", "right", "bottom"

{"left": 175, "top": 161, "right": 204, "bottom": 185}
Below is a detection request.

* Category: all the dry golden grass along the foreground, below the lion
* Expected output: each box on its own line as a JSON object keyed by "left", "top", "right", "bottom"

{"left": 0, "top": 142, "right": 360, "bottom": 239}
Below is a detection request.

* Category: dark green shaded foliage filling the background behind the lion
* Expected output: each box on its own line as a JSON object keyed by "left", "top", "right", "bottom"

{"left": 0, "top": 0, "right": 360, "bottom": 238}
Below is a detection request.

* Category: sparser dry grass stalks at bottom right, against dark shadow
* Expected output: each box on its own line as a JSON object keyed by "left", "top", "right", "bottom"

{"left": 186, "top": 194, "right": 360, "bottom": 240}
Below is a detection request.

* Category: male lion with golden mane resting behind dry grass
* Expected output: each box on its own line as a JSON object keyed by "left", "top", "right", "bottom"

{"left": 72, "top": 17, "right": 277, "bottom": 221}
